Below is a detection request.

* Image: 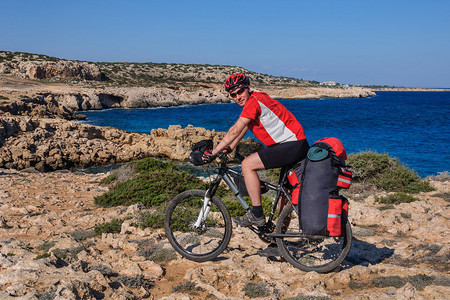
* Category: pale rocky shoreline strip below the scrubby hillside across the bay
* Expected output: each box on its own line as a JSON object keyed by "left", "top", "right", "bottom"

{"left": 0, "top": 75, "right": 375, "bottom": 111}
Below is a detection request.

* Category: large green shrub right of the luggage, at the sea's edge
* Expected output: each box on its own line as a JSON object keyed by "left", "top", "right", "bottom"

{"left": 347, "top": 151, "right": 433, "bottom": 193}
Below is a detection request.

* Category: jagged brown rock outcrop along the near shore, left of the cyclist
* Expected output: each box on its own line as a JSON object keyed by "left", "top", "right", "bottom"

{"left": 0, "top": 96, "right": 262, "bottom": 171}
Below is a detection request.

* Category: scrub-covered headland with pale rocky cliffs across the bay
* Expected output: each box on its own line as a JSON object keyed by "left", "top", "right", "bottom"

{"left": 0, "top": 51, "right": 375, "bottom": 110}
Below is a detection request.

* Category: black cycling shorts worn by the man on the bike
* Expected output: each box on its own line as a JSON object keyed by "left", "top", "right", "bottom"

{"left": 258, "top": 139, "right": 309, "bottom": 170}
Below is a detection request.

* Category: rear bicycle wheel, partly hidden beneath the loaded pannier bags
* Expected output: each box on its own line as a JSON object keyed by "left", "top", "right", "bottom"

{"left": 275, "top": 204, "right": 352, "bottom": 273}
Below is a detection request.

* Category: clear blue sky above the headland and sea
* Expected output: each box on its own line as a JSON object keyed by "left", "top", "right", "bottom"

{"left": 0, "top": 0, "right": 450, "bottom": 88}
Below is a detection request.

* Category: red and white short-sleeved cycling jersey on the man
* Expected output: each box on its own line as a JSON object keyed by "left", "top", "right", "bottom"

{"left": 241, "top": 92, "right": 306, "bottom": 146}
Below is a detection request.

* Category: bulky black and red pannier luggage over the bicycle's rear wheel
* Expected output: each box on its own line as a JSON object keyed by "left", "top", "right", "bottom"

{"left": 288, "top": 137, "right": 351, "bottom": 236}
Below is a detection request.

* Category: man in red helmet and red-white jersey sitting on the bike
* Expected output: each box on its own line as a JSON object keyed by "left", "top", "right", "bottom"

{"left": 203, "top": 73, "right": 309, "bottom": 227}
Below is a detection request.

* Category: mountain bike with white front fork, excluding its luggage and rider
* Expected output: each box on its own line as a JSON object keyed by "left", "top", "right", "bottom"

{"left": 164, "top": 154, "right": 352, "bottom": 273}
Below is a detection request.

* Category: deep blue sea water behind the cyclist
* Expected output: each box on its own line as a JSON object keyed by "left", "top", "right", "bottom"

{"left": 81, "top": 92, "right": 450, "bottom": 177}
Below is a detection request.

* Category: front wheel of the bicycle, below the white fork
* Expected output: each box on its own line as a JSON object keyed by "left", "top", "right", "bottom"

{"left": 164, "top": 190, "right": 232, "bottom": 262}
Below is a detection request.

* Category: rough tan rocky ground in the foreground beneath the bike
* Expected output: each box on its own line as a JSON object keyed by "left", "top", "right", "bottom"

{"left": 0, "top": 169, "right": 450, "bottom": 299}
